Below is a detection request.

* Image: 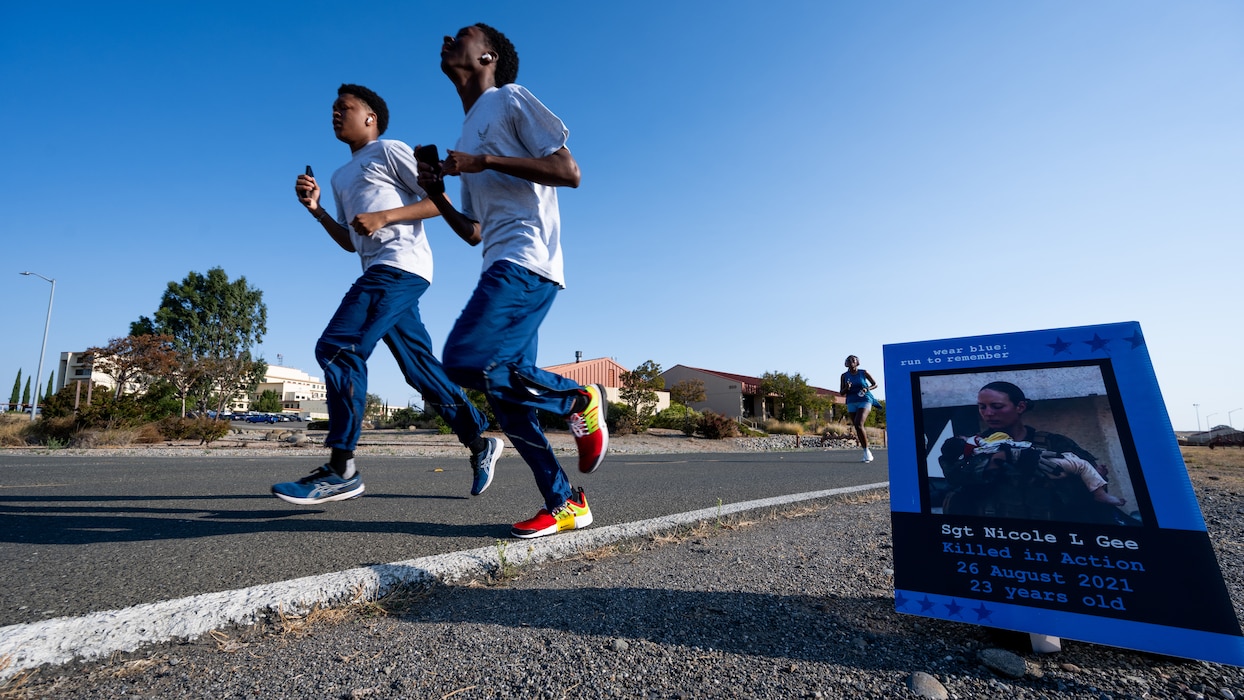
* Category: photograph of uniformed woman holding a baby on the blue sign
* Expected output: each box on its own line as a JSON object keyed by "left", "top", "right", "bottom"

{"left": 916, "top": 362, "right": 1148, "bottom": 526}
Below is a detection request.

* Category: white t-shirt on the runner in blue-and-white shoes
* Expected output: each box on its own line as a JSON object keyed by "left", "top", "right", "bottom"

{"left": 332, "top": 139, "right": 432, "bottom": 282}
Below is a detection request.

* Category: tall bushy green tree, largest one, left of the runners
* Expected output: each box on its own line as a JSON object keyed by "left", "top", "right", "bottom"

{"left": 129, "top": 267, "right": 267, "bottom": 410}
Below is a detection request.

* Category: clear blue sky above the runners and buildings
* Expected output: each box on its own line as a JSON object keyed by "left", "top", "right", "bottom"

{"left": 0, "top": 0, "right": 1244, "bottom": 429}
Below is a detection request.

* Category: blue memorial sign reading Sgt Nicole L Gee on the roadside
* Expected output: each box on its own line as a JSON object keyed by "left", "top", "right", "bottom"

{"left": 883, "top": 322, "right": 1244, "bottom": 665}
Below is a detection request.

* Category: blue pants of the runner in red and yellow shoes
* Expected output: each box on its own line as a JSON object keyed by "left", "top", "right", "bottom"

{"left": 443, "top": 261, "right": 581, "bottom": 512}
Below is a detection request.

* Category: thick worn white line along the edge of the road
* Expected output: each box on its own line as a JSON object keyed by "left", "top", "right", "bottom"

{"left": 0, "top": 481, "right": 889, "bottom": 680}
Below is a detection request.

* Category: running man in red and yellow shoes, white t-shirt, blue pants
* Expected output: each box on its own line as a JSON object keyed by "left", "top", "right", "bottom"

{"left": 419, "top": 24, "right": 608, "bottom": 537}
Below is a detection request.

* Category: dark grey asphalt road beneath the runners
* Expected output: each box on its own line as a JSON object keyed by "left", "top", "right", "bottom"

{"left": 0, "top": 450, "right": 887, "bottom": 625}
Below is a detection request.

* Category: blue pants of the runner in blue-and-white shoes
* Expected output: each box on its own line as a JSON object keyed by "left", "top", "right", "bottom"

{"left": 315, "top": 265, "right": 488, "bottom": 450}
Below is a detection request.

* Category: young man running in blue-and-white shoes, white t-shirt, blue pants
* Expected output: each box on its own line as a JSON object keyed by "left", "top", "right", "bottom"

{"left": 272, "top": 85, "right": 503, "bottom": 505}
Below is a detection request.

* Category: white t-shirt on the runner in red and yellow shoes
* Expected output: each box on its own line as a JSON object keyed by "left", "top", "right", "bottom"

{"left": 454, "top": 83, "right": 570, "bottom": 287}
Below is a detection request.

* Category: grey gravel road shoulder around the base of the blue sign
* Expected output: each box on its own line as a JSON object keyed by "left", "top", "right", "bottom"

{"left": 6, "top": 447, "right": 1244, "bottom": 700}
